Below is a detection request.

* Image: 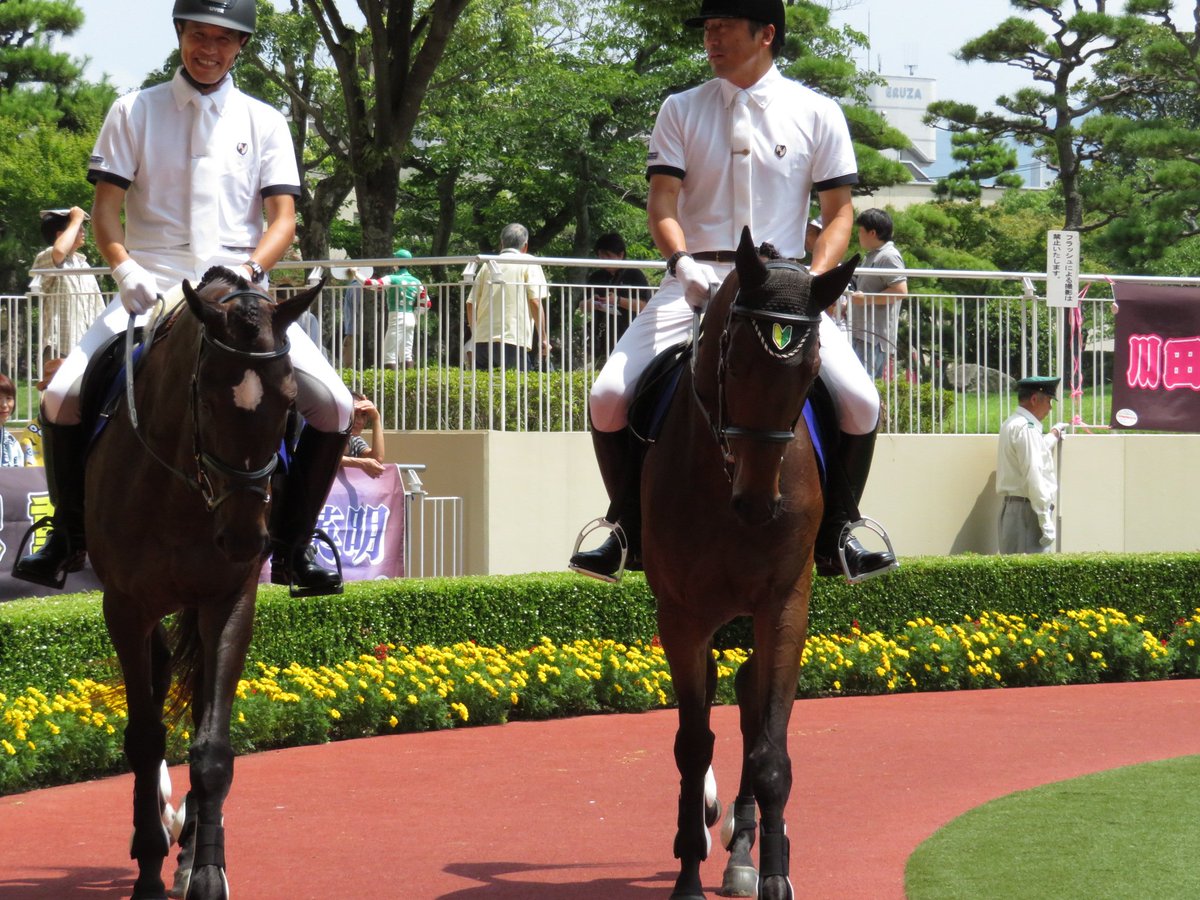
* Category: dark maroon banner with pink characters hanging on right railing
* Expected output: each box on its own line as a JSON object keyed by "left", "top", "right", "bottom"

{"left": 1111, "top": 282, "right": 1200, "bottom": 432}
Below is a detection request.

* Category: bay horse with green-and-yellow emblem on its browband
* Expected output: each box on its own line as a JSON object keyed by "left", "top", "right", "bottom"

{"left": 642, "top": 230, "right": 857, "bottom": 900}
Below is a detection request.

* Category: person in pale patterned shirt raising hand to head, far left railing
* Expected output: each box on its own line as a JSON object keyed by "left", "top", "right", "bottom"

{"left": 29, "top": 206, "right": 104, "bottom": 364}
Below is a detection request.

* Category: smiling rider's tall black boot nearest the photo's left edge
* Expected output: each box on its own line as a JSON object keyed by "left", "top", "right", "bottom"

{"left": 12, "top": 419, "right": 88, "bottom": 588}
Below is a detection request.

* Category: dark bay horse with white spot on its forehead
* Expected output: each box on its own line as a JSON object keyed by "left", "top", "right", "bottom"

{"left": 86, "top": 268, "right": 320, "bottom": 900}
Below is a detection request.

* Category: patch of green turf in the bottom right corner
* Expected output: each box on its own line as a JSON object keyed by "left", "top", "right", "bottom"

{"left": 905, "top": 756, "right": 1200, "bottom": 900}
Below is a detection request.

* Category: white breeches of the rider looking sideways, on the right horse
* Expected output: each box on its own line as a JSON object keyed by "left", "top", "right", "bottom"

{"left": 588, "top": 265, "right": 880, "bottom": 434}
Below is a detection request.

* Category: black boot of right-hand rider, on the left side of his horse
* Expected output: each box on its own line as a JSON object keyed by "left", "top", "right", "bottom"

{"left": 569, "top": 428, "right": 642, "bottom": 581}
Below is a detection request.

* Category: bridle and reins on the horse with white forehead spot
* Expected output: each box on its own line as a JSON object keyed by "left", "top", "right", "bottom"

{"left": 126, "top": 289, "right": 292, "bottom": 512}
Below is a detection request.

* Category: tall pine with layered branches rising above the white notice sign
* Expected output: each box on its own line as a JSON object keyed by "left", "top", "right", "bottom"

{"left": 926, "top": 0, "right": 1144, "bottom": 230}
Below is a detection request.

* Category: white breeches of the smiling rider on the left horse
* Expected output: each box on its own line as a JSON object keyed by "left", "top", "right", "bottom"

{"left": 42, "top": 244, "right": 354, "bottom": 433}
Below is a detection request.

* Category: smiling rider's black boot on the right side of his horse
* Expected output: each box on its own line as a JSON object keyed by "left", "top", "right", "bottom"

{"left": 271, "top": 427, "right": 347, "bottom": 596}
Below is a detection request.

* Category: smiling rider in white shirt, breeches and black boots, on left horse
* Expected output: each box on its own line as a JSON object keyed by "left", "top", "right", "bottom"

{"left": 13, "top": 0, "right": 353, "bottom": 594}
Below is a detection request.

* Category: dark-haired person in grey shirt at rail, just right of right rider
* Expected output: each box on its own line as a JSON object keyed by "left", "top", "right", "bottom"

{"left": 848, "top": 209, "right": 908, "bottom": 378}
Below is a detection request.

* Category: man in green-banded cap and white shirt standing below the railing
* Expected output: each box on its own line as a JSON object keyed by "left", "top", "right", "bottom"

{"left": 996, "top": 377, "right": 1062, "bottom": 553}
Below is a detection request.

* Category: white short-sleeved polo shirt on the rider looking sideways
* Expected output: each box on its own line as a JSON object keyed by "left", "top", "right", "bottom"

{"left": 646, "top": 66, "right": 858, "bottom": 259}
